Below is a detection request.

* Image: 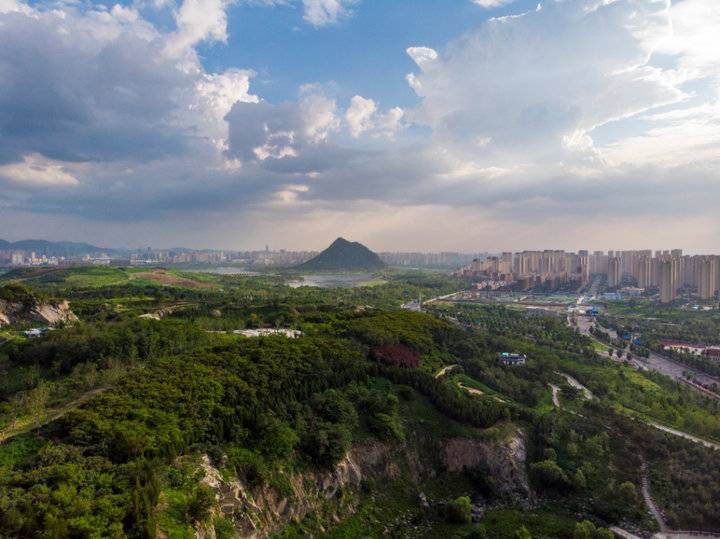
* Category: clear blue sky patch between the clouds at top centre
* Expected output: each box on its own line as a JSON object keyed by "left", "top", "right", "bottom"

{"left": 200, "top": 0, "right": 530, "bottom": 106}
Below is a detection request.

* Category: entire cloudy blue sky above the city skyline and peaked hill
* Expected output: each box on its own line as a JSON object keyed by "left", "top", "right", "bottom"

{"left": 0, "top": 0, "right": 720, "bottom": 253}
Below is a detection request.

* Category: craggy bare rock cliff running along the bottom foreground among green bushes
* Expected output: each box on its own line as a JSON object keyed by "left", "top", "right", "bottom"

{"left": 196, "top": 432, "right": 530, "bottom": 539}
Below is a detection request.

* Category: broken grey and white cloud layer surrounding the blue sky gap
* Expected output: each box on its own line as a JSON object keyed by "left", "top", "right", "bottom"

{"left": 0, "top": 0, "right": 720, "bottom": 249}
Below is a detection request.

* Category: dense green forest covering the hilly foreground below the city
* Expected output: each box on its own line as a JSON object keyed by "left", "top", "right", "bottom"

{"left": 0, "top": 270, "right": 720, "bottom": 538}
